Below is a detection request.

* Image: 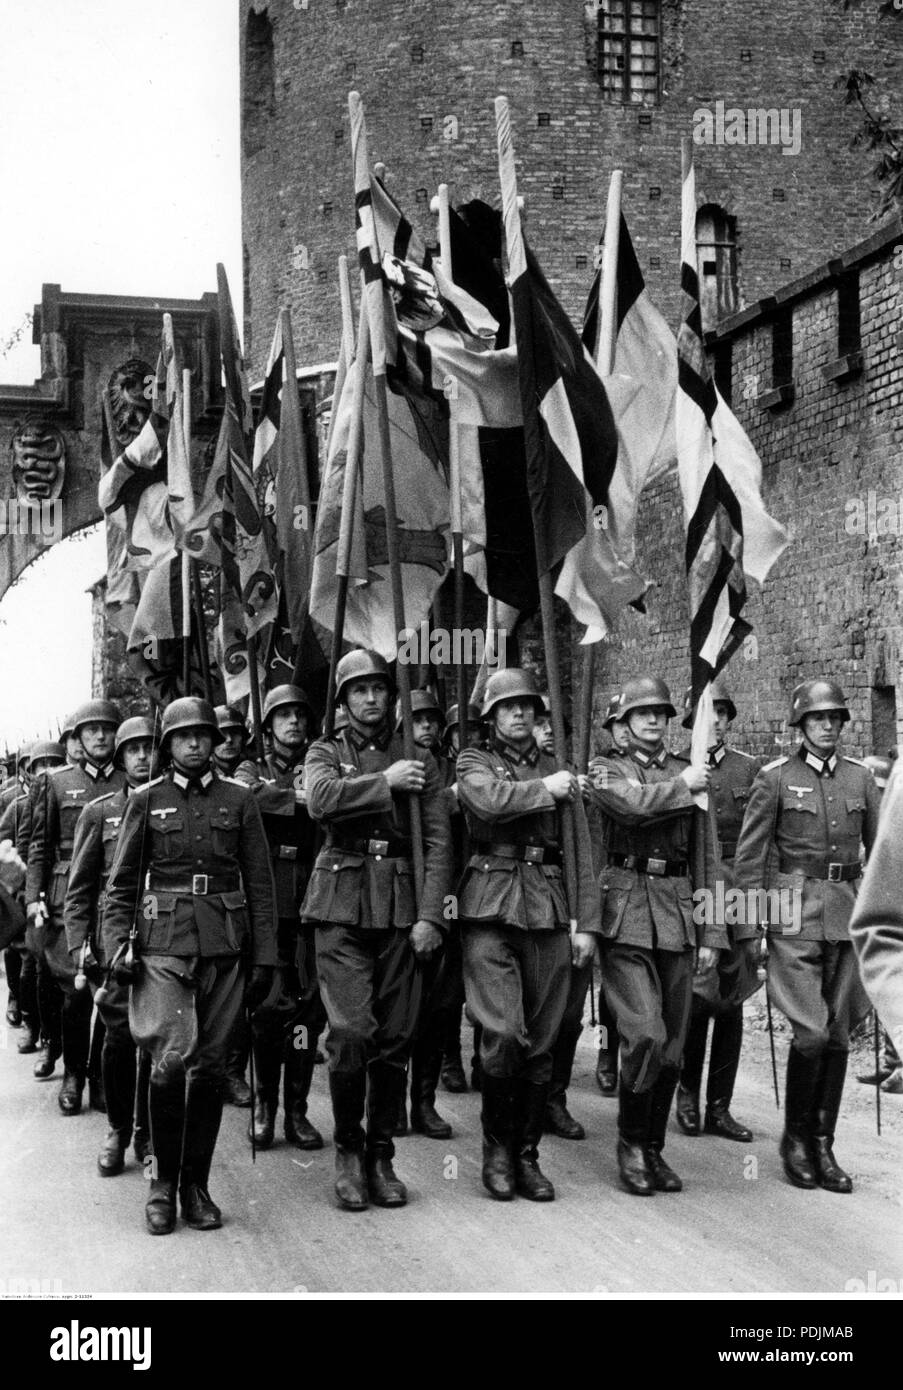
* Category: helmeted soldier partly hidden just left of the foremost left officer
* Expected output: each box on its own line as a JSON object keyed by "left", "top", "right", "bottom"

{"left": 64, "top": 714, "right": 157, "bottom": 1177}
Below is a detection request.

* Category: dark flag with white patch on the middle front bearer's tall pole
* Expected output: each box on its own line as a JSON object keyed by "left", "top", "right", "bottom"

{"left": 496, "top": 99, "right": 646, "bottom": 632}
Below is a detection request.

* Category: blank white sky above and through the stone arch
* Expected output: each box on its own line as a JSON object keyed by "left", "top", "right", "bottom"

{"left": 0, "top": 0, "right": 242, "bottom": 751}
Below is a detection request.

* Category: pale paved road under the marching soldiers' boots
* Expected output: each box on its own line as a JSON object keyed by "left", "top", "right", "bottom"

{"left": 0, "top": 1011, "right": 903, "bottom": 1294}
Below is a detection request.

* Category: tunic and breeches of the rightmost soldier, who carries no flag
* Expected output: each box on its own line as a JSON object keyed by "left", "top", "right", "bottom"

{"left": 734, "top": 746, "right": 881, "bottom": 1055}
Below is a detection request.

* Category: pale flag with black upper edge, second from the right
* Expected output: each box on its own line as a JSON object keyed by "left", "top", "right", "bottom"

{"left": 583, "top": 215, "right": 678, "bottom": 564}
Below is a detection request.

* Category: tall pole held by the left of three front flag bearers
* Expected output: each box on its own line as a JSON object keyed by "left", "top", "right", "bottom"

{"left": 349, "top": 92, "right": 424, "bottom": 915}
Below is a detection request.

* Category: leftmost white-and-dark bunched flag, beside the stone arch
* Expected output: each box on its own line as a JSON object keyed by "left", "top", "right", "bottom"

{"left": 97, "top": 314, "right": 194, "bottom": 570}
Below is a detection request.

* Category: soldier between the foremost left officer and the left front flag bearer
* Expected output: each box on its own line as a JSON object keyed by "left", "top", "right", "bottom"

{"left": 236, "top": 685, "right": 326, "bottom": 1148}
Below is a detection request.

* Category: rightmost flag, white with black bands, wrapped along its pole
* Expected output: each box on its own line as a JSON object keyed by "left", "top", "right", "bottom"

{"left": 677, "top": 149, "right": 789, "bottom": 742}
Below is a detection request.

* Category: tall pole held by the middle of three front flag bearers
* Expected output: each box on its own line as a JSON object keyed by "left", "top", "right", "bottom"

{"left": 495, "top": 96, "right": 578, "bottom": 934}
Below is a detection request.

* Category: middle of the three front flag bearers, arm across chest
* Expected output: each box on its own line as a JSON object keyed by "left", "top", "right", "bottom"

{"left": 457, "top": 669, "right": 599, "bottom": 1201}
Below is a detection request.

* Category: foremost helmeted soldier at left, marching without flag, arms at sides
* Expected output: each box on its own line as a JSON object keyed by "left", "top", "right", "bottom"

{"left": 101, "top": 696, "right": 276, "bottom": 1236}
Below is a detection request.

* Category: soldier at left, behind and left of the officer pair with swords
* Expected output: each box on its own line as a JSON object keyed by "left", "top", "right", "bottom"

{"left": 25, "top": 699, "right": 125, "bottom": 1116}
